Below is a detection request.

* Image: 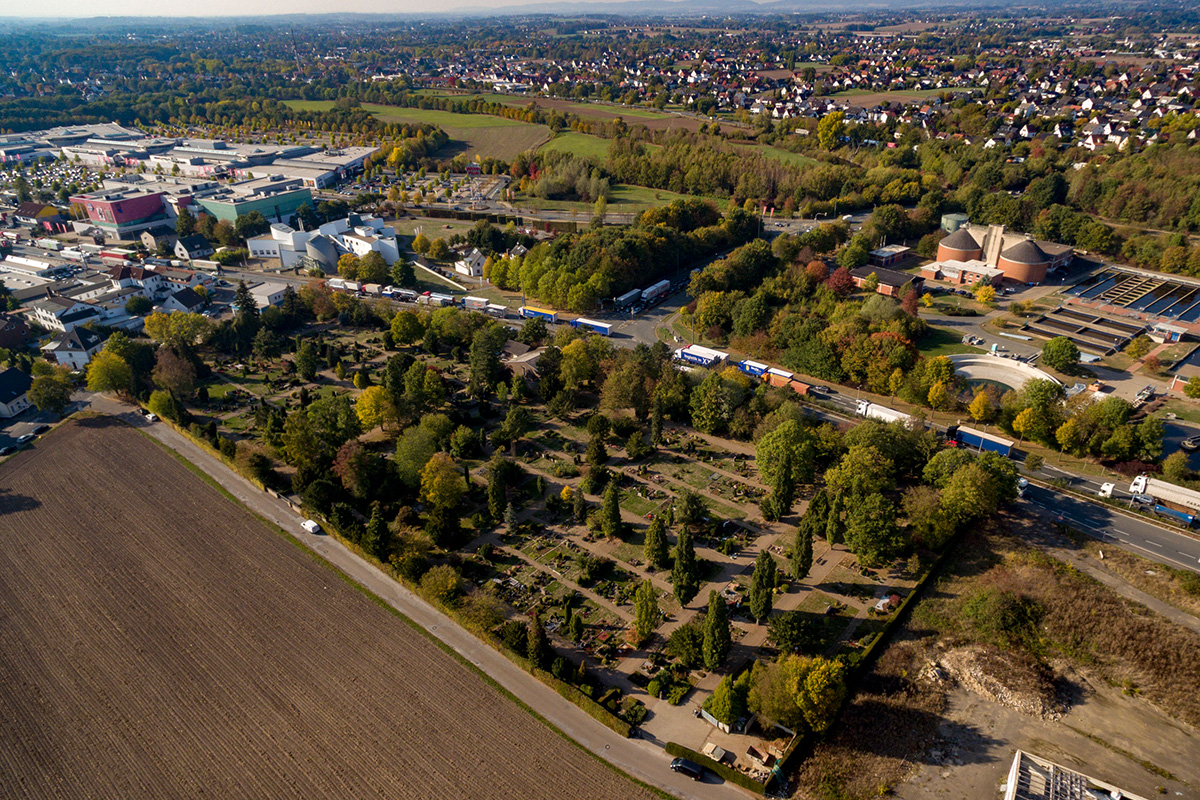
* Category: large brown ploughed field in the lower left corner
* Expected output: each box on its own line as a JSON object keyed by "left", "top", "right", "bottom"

{"left": 0, "top": 417, "right": 653, "bottom": 799}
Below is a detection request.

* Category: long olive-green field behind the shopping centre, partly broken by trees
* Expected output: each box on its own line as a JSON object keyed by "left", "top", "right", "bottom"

{"left": 287, "top": 100, "right": 550, "bottom": 158}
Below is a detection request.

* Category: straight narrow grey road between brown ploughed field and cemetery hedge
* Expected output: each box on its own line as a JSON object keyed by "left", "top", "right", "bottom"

{"left": 77, "top": 393, "right": 751, "bottom": 800}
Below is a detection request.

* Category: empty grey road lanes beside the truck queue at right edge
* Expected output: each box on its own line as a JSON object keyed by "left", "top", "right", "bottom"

{"left": 1024, "top": 485, "right": 1200, "bottom": 572}
